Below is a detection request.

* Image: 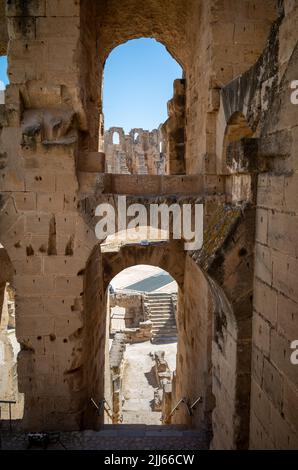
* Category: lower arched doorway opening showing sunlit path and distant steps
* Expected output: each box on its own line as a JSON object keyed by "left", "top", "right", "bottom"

{"left": 105, "top": 265, "right": 178, "bottom": 425}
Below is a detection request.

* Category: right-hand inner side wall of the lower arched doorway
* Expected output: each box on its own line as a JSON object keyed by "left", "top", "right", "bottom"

{"left": 172, "top": 256, "right": 213, "bottom": 436}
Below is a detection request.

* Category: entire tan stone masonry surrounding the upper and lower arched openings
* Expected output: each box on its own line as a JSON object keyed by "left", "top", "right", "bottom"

{"left": 0, "top": 0, "right": 298, "bottom": 449}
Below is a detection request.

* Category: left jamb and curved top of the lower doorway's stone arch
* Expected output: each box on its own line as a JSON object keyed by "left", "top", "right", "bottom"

{"left": 83, "top": 241, "right": 185, "bottom": 428}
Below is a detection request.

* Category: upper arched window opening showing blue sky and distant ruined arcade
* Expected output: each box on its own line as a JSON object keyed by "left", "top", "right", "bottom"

{"left": 103, "top": 38, "right": 184, "bottom": 174}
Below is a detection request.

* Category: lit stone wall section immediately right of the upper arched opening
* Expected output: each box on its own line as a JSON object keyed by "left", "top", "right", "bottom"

{"left": 185, "top": 0, "right": 277, "bottom": 176}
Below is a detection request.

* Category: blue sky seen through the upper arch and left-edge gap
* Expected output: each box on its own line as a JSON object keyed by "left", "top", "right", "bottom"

{"left": 0, "top": 39, "right": 182, "bottom": 132}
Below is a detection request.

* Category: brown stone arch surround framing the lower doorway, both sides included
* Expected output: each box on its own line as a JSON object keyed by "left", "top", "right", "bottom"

{"left": 84, "top": 240, "right": 213, "bottom": 444}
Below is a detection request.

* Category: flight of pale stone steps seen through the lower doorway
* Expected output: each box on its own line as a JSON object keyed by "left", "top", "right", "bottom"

{"left": 145, "top": 292, "right": 177, "bottom": 343}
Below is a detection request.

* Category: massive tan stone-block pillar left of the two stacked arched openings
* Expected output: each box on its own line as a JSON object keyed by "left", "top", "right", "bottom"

{"left": 0, "top": 0, "right": 98, "bottom": 431}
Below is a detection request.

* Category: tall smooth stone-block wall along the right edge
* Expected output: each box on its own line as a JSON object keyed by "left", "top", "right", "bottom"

{"left": 250, "top": 1, "right": 298, "bottom": 449}
